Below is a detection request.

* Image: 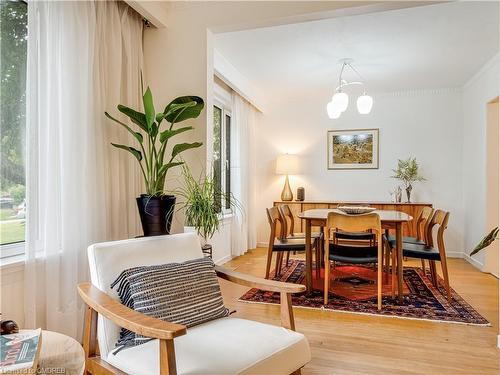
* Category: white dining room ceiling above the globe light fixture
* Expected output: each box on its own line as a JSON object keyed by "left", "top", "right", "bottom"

{"left": 215, "top": 1, "right": 500, "bottom": 96}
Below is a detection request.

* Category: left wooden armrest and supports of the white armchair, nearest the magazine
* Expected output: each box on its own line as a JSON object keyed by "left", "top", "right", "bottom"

{"left": 78, "top": 283, "right": 186, "bottom": 375}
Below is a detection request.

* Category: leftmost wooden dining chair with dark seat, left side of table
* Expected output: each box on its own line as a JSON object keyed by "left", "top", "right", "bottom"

{"left": 266, "top": 207, "right": 317, "bottom": 279}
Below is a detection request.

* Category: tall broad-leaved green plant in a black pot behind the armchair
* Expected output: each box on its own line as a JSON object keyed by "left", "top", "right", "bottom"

{"left": 104, "top": 87, "right": 204, "bottom": 236}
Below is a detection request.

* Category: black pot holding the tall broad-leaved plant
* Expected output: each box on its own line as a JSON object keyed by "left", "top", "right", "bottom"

{"left": 136, "top": 194, "right": 175, "bottom": 237}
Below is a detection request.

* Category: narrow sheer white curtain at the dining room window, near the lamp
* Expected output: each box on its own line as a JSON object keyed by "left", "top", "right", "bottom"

{"left": 231, "top": 91, "right": 258, "bottom": 256}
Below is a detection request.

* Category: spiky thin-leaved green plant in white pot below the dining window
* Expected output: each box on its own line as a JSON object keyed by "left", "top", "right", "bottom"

{"left": 176, "top": 165, "right": 240, "bottom": 245}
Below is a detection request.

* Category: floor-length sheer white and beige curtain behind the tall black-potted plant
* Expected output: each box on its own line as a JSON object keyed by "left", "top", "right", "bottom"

{"left": 25, "top": 1, "right": 142, "bottom": 337}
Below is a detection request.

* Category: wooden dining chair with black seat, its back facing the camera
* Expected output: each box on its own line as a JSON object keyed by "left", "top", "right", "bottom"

{"left": 324, "top": 212, "right": 386, "bottom": 310}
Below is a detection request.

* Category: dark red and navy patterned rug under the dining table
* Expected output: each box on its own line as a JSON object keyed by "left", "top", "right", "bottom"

{"left": 240, "top": 259, "right": 490, "bottom": 325}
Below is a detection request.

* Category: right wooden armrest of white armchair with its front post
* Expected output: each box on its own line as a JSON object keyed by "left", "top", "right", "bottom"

{"left": 215, "top": 266, "right": 306, "bottom": 331}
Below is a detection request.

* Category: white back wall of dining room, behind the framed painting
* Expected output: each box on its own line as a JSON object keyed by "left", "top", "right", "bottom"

{"left": 256, "top": 89, "right": 464, "bottom": 256}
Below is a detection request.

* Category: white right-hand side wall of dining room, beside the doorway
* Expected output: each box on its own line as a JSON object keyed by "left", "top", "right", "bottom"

{"left": 462, "top": 54, "right": 500, "bottom": 268}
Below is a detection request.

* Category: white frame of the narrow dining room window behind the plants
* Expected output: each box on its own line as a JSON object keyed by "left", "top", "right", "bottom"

{"left": 212, "top": 94, "right": 233, "bottom": 216}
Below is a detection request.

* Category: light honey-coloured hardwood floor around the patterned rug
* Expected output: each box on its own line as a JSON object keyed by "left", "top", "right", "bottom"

{"left": 221, "top": 249, "right": 500, "bottom": 375}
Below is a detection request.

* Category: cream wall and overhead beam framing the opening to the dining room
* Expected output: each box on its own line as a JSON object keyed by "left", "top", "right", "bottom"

{"left": 140, "top": 1, "right": 422, "bottom": 232}
